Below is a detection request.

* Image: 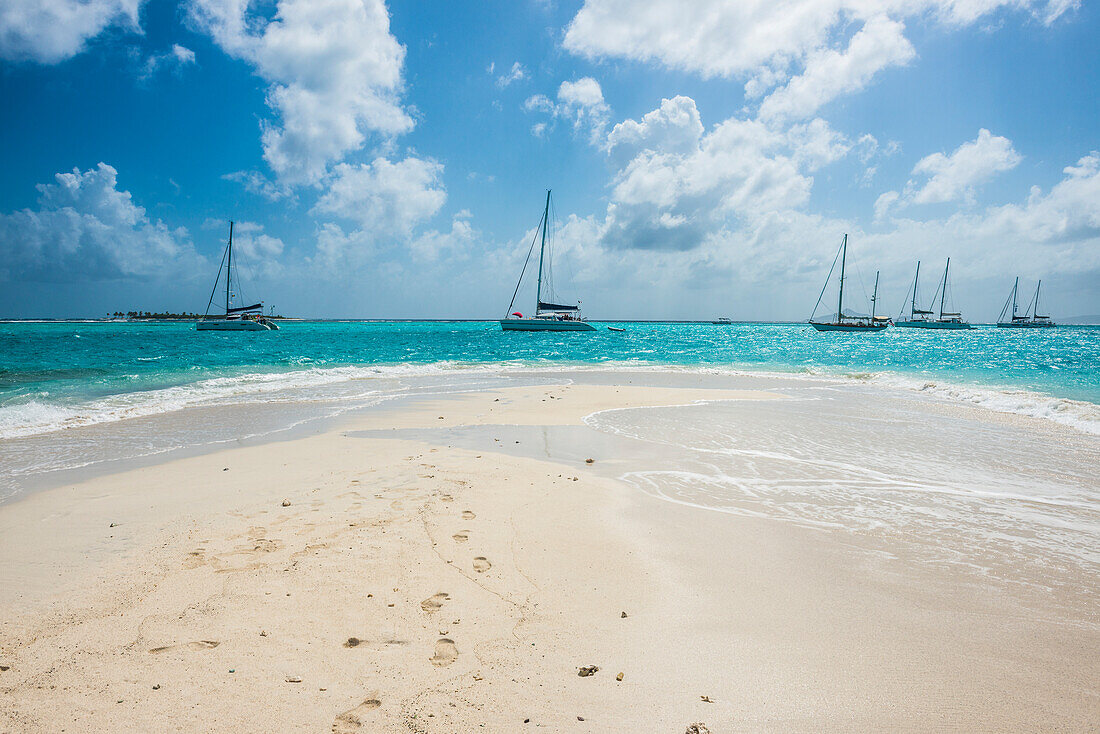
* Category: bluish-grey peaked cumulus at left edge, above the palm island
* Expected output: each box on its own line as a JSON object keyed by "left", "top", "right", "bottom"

{"left": 0, "top": 163, "right": 201, "bottom": 282}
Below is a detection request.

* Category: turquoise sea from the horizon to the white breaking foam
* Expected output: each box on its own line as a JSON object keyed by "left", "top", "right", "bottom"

{"left": 0, "top": 321, "right": 1100, "bottom": 438}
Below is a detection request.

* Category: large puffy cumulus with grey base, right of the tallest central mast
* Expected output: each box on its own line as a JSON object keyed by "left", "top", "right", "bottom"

{"left": 600, "top": 96, "right": 850, "bottom": 251}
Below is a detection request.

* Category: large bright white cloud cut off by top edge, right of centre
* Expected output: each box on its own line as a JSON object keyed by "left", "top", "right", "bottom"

{"left": 563, "top": 0, "right": 1077, "bottom": 130}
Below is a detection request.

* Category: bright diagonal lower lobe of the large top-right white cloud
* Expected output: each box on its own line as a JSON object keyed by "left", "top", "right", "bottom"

{"left": 760, "top": 17, "right": 916, "bottom": 120}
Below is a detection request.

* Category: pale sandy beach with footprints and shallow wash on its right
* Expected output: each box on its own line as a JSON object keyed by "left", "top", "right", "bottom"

{"left": 0, "top": 373, "right": 1100, "bottom": 734}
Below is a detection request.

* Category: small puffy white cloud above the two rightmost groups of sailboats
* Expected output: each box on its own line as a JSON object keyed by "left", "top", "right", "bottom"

{"left": 909, "top": 128, "right": 1023, "bottom": 204}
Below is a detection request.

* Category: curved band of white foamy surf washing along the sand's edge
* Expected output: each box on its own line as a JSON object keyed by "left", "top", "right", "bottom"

{"left": 0, "top": 362, "right": 1100, "bottom": 506}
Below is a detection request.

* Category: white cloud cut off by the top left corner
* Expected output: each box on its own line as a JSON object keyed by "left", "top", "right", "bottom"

{"left": 0, "top": 0, "right": 142, "bottom": 64}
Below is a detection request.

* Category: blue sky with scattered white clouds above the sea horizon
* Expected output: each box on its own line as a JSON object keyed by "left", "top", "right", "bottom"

{"left": 0, "top": 0, "right": 1100, "bottom": 321}
